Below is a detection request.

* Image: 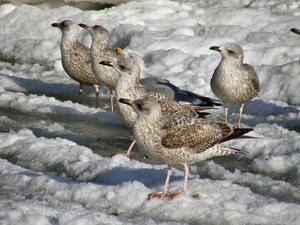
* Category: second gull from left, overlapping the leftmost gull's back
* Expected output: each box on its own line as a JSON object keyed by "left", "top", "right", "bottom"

{"left": 79, "top": 24, "right": 120, "bottom": 112}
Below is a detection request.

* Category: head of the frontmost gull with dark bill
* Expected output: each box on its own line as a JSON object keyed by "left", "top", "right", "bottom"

{"left": 119, "top": 98, "right": 161, "bottom": 116}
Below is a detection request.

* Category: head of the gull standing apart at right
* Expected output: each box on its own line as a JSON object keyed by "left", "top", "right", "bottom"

{"left": 209, "top": 43, "right": 244, "bottom": 63}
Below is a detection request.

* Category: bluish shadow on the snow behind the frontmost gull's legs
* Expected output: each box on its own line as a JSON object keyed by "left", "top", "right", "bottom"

{"left": 92, "top": 167, "right": 183, "bottom": 187}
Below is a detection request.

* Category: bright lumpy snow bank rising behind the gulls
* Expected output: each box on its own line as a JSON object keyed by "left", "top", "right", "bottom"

{"left": 0, "top": 0, "right": 300, "bottom": 105}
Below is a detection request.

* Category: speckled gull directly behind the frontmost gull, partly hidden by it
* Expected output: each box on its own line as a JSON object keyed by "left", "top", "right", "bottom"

{"left": 100, "top": 54, "right": 211, "bottom": 157}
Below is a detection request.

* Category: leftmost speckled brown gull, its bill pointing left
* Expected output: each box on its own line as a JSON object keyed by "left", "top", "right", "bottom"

{"left": 52, "top": 20, "right": 101, "bottom": 106}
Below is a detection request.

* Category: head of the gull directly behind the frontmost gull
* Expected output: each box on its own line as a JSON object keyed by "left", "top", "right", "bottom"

{"left": 99, "top": 54, "right": 141, "bottom": 79}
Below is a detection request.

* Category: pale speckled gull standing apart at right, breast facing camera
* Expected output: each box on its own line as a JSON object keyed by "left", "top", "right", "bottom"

{"left": 210, "top": 43, "right": 259, "bottom": 127}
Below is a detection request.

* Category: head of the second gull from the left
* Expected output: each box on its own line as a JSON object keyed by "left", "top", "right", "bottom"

{"left": 78, "top": 23, "right": 109, "bottom": 45}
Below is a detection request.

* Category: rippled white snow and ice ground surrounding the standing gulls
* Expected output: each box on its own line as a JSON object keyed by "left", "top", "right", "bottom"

{"left": 0, "top": 0, "right": 300, "bottom": 225}
